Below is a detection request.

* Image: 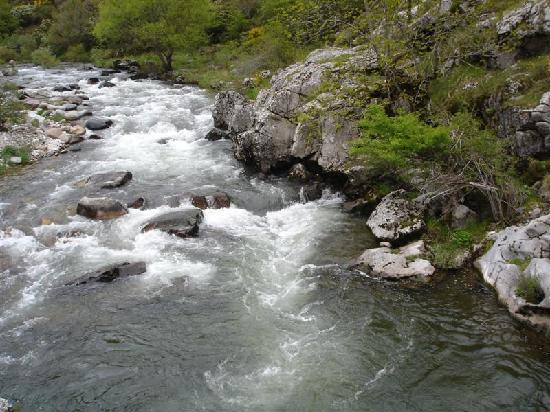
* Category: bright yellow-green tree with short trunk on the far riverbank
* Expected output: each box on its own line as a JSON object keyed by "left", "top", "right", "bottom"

{"left": 94, "top": 0, "right": 213, "bottom": 71}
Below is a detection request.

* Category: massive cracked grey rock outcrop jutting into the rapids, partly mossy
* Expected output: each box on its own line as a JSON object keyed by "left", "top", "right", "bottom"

{"left": 214, "top": 48, "right": 377, "bottom": 173}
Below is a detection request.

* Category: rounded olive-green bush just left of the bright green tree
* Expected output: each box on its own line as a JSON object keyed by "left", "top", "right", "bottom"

{"left": 47, "top": 0, "right": 97, "bottom": 56}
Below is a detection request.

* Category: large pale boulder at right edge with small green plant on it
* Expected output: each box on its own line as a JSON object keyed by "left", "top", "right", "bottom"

{"left": 475, "top": 215, "right": 550, "bottom": 329}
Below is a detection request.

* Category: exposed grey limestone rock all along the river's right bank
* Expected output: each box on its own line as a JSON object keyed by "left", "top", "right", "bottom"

{"left": 208, "top": 2, "right": 550, "bottom": 334}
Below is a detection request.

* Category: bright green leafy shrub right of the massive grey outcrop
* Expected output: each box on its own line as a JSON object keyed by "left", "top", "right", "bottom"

{"left": 350, "top": 105, "right": 450, "bottom": 173}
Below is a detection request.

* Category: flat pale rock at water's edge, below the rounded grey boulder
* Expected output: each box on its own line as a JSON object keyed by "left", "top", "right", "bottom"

{"left": 353, "top": 240, "right": 435, "bottom": 280}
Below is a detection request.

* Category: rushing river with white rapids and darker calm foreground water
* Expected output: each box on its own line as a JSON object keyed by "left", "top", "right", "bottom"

{"left": 0, "top": 68, "right": 550, "bottom": 411}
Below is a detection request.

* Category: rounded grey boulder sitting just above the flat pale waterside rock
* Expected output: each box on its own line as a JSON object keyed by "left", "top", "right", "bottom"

{"left": 367, "top": 190, "right": 425, "bottom": 242}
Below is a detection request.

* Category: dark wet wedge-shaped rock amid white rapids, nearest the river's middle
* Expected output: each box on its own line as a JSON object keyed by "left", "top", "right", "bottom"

{"left": 142, "top": 208, "right": 204, "bottom": 239}
